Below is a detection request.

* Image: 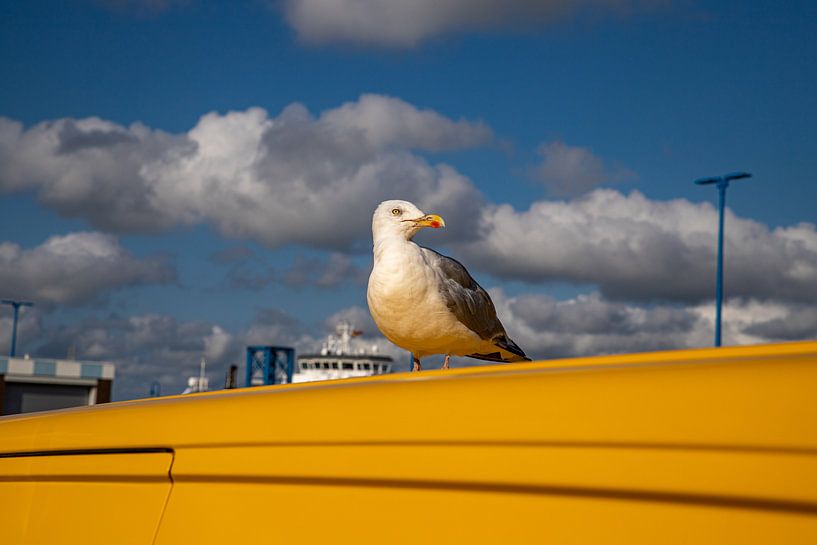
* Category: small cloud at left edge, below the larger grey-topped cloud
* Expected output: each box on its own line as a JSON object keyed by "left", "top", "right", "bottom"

{"left": 0, "top": 232, "right": 175, "bottom": 305}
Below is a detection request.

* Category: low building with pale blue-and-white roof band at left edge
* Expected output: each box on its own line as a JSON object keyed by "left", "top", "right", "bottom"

{"left": 0, "top": 357, "right": 114, "bottom": 415}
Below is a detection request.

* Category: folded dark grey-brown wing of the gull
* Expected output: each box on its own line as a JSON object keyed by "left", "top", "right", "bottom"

{"left": 423, "top": 248, "right": 505, "bottom": 340}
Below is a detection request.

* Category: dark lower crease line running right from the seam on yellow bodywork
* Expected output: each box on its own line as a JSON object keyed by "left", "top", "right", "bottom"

{"left": 176, "top": 474, "right": 817, "bottom": 517}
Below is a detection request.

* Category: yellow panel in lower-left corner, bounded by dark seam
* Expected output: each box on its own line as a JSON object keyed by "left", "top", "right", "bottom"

{"left": 0, "top": 453, "right": 173, "bottom": 545}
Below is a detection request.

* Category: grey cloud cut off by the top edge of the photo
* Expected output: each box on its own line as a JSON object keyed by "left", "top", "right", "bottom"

{"left": 284, "top": 0, "right": 667, "bottom": 47}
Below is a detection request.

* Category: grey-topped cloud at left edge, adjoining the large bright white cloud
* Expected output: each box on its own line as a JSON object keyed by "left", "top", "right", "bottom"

{"left": 0, "top": 117, "right": 187, "bottom": 232}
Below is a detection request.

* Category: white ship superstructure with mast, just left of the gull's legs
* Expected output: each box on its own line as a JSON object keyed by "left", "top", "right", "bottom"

{"left": 292, "top": 322, "right": 394, "bottom": 382}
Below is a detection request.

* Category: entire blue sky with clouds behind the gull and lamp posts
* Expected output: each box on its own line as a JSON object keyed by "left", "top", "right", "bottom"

{"left": 0, "top": 0, "right": 817, "bottom": 398}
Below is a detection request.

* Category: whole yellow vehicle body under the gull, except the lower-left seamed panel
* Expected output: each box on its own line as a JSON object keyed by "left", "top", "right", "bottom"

{"left": 0, "top": 342, "right": 817, "bottom": 544}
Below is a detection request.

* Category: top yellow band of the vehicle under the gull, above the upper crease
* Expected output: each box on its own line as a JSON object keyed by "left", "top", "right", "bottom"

{"left": 0, "top": 342, "right": 817, "bottom": 454}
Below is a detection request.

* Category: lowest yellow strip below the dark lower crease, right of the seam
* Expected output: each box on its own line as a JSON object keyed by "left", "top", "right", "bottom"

{"left": 156, "top": 482, "right": 817, "bottom": 545}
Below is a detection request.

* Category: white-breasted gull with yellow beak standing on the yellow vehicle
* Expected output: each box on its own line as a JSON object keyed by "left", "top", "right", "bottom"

{"left": 366, "top": 200, "right": 530, "bottom": 371}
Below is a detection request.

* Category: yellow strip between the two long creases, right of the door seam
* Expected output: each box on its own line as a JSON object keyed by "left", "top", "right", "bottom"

{"left": 173, "top": 444, "right": 817, "bottom": 504}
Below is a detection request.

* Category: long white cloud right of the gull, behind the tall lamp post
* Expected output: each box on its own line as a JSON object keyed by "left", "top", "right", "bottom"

{"left": 455, "top": 190, "right": 817, "bottom": 302}
